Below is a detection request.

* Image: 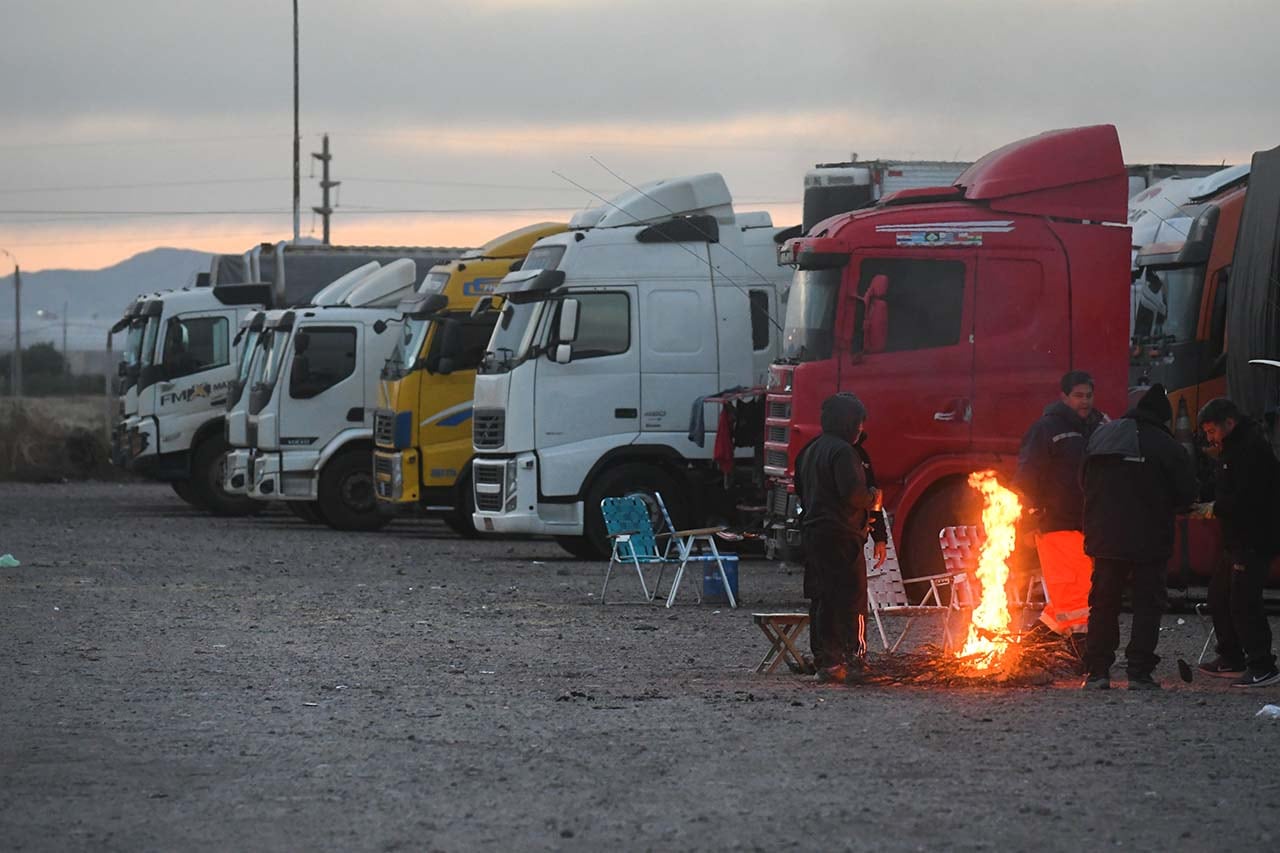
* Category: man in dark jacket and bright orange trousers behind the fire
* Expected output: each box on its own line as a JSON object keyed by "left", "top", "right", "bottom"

{"left": 1014, "top": 370, "right": 1106, "bottom": 634}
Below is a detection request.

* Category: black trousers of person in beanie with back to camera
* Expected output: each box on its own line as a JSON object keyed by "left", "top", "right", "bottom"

{"left": 1084, "top": 557, "right": 1167, "bottom": 678}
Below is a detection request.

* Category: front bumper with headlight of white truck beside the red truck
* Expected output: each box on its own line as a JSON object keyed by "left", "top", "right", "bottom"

{"left": 471, "top": 453, "right": 582, "bottom": 537}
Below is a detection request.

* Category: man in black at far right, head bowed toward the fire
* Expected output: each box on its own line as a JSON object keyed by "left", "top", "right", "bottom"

{"left": 1199, "top": 397, "right": 1280, "bottom": 686}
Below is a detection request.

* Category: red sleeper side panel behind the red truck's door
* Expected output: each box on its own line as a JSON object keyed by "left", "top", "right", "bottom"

{"left": 973, "top": 252, "right": 1070, "bottom": 453}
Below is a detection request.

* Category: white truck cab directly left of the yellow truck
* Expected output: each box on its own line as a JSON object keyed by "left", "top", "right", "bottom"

{"left": 246, "top": 259, "right": 425, "bottom": 530}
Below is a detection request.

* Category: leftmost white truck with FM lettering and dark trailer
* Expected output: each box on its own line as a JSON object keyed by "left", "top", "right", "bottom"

{"left": 116, "top": 243, "right": 462, "bottom": 515}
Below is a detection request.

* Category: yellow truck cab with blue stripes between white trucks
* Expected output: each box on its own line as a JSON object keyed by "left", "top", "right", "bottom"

{"left": 374, "top": 223, "right": 567, "bottom": 535}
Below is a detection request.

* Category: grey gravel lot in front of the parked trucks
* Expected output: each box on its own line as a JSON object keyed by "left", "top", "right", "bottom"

{"left": 0, "top": 484, "right": 1280, "bottom": 850}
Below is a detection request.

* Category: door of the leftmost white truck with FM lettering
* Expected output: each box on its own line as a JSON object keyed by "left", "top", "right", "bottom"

{"left": 155, "top": 311, "right": 237, "bottom": 453}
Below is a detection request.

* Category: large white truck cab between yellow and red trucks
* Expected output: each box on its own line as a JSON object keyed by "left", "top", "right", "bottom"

{"left": 472, "top": 173, "right": 790, "bottom": 556}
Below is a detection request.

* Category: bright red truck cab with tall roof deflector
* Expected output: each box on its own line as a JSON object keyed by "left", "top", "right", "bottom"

{"left": 764, "top": 126, "right": 1130, "bottom": 576}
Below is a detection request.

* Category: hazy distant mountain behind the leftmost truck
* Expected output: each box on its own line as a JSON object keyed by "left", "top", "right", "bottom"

{"left": 0, "top": 248, "right": 212, "bottom": 350}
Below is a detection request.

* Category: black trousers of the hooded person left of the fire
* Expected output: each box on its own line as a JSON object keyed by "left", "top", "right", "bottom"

{"left": 801, "top": 530, "right": 867, "bottom": 669}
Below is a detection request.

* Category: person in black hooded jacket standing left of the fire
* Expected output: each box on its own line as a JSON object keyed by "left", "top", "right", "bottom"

{"left": 796, "top": 393, "right": 879, "bottom": 683}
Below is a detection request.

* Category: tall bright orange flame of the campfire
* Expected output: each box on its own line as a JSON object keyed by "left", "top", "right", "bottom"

{"left": 956, "top": 471, "right": 1023, "bottom": 670}
